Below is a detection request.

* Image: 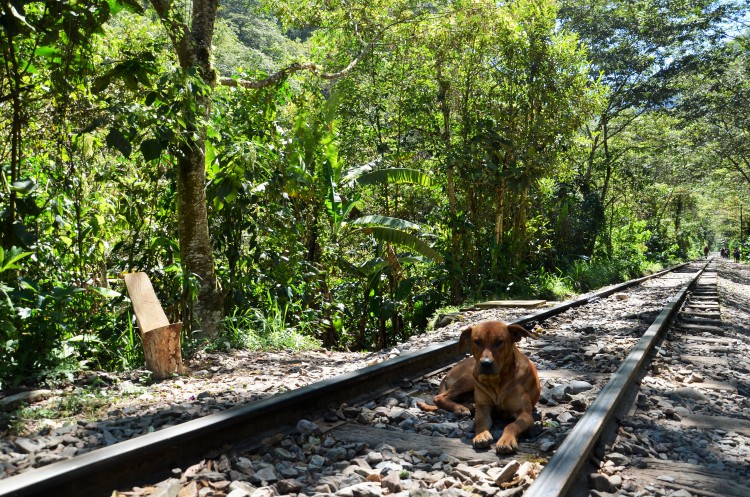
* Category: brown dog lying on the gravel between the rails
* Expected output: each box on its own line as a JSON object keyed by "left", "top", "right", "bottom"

{"left": 419, "top": 321, "right": 541, "bottom": 454}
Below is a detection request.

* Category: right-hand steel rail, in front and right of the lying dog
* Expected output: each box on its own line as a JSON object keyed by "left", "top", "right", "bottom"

{"left": 524, "top": 261, "right": 711, "bottom": 497}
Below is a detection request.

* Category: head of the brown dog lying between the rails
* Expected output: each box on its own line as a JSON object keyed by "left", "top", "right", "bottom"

{"left": 458, "top": 321, "right": 538, "bottom": 375}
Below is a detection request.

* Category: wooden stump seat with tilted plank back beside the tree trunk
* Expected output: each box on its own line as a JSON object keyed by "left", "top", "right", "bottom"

{"left": 124, "top": 273, "right": 183, "bottom": 379}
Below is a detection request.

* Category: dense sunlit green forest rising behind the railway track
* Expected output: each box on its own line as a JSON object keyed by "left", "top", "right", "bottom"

{"left": 0, "top": 0, "right": 750, "bottom": 388}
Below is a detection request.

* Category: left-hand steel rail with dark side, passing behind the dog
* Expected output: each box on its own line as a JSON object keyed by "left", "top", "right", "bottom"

{"left": 0, "top": 263, "right": 700, "bottom": 497}
